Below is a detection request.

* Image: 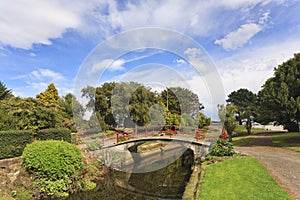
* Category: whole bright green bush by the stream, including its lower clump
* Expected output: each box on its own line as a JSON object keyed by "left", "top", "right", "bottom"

{"left": 22, "top": 140, "right": 83, "bottom": 197}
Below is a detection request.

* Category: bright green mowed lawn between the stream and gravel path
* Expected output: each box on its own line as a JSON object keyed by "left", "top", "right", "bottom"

{"left": 200, "top": 157, "right": 292, "bottom": 200}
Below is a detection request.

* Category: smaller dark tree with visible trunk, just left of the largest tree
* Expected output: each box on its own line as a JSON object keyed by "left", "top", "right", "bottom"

{"left": 227, "top": 88, "right": 257, "bottom": 135}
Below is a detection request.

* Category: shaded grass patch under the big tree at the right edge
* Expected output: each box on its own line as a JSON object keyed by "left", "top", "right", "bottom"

{"left": 272, "top": 132, "right": 300, "bottom": 152}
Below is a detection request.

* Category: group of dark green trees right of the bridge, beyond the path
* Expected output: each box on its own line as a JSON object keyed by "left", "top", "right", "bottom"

{"left": 218, "top": 53, "right": 300, "bottom": 141}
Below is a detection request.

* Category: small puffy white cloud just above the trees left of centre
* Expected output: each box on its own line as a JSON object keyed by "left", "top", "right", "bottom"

{"left": 91, "top": 59, "right": 125, "bottom": 73}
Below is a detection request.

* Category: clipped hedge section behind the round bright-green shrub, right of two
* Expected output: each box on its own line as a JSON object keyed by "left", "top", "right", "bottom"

{"left": 36, "top": 128, "right": 71, "bottom": 143}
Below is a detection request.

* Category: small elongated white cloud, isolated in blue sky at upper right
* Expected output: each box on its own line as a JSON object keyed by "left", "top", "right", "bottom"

{"left": 215, "top": 23, "right": 262, "bottom": 50}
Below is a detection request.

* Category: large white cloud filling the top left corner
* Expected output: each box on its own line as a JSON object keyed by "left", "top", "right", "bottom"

{"left": 0, "top": 0, "right": 80, "bottom": 49}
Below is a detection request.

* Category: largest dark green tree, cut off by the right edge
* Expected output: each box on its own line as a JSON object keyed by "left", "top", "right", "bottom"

{"left": 258, "top": 53, "right": 300, "bottom": 131}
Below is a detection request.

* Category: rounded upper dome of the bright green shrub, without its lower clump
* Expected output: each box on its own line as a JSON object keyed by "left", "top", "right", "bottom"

{"left": 22, "top": 140, "right": 84, "bottom": 181}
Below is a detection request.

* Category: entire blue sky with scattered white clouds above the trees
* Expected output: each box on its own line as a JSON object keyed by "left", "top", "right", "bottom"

{"left": 0, "top": 0, "right": 300, "bottom": 120}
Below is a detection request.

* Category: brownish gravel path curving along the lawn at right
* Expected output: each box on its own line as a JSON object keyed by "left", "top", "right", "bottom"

{"left": 235, "top": 135, "right": 300, "bottom": 200}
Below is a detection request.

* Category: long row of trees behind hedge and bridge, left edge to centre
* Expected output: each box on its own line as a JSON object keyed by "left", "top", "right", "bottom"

{"left": 0, "top": 82, "right": 211, "bottom": 131}
